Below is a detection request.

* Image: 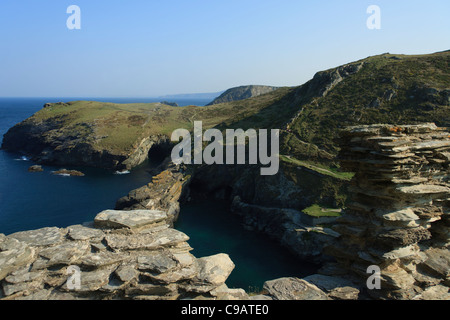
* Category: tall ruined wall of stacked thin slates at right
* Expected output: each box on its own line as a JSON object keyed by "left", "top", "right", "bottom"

{"left": 326, "top": 124, "right": 450, "bottom": 299}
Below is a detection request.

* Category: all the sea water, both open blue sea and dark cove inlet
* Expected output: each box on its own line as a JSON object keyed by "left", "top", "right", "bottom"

{"left": 0, "top": 97, "right": 317, "bottom": 292}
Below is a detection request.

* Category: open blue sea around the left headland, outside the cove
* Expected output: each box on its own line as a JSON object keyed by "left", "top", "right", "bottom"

{"left": 0, "top": 98, "right": 209, "bottom": 234}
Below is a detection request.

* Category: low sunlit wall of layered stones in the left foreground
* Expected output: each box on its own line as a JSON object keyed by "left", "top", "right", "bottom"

{"left": 0, "top": 210, "right": 248, "bottom": 300}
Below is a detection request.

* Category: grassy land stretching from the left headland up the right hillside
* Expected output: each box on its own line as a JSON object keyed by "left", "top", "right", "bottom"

{"left": 2, "top": 51, "right": 450, "bottom": 170}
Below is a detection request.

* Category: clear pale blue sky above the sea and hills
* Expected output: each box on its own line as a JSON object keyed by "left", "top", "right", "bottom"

{"left": 0, "top": 0, "right": 450, "bottom": 97}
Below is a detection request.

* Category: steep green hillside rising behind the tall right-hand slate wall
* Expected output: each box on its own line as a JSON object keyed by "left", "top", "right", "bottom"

{"left": 282, "top": 51, "right": 450, "bottom": 165}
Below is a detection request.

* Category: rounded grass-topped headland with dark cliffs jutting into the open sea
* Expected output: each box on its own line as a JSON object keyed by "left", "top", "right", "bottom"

{"left": 2, "top": 102, "right": 171, "bottom": 170}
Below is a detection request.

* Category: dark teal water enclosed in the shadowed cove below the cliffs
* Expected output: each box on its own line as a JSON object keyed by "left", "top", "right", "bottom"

{"left": 175, "top": 201, "right": 317, "bottom": 292}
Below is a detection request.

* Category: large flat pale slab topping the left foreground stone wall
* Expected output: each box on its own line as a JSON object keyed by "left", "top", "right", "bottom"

{"left": 94, "top": 210, "right": 167, "bottom": 229}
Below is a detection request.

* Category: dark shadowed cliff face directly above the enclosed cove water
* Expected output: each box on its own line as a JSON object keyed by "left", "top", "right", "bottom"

{"left": 186, "top": 163, "right": 344, "bottom": 263}
